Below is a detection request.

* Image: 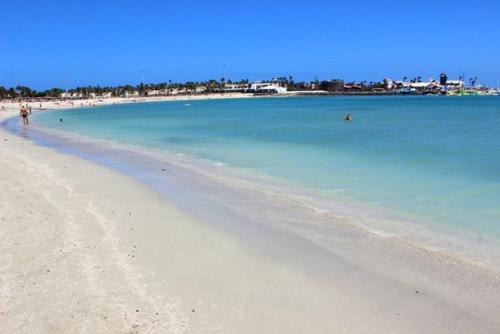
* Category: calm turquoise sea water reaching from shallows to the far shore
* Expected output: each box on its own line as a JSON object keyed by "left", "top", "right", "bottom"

{"left": 33, "top": 97, "right": 500, "bottom": 238}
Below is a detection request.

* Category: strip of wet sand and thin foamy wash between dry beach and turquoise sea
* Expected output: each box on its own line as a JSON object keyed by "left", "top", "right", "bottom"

{"left": 2, "top": 115, "right": 500, "bottom": 269}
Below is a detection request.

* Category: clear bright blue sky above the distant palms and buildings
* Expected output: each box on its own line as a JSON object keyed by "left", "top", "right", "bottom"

{"left": 0, "top": 0, "right": 500, "bottom": 89}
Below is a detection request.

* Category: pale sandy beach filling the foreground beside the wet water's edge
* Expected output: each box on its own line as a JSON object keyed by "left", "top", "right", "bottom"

{"left": 0, "top": 103, "right": 500, "bottom": 333}
